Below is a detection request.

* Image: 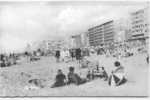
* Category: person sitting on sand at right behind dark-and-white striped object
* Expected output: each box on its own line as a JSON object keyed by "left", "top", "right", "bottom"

{"left": 108, "top": 61, "right": 127, "bottom": 86}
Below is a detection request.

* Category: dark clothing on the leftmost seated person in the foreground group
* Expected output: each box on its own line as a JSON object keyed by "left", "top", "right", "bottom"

{"left": 52, "top": 74, "right": 66, "bottom": 88}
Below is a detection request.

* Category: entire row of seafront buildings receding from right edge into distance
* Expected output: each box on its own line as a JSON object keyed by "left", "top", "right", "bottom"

{"left": 28, "top": 8, "right": 149, "bottom": 51}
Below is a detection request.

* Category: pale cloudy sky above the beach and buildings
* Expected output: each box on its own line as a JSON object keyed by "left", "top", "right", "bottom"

{"left": 0, "top": 2, "right": 147, "bottom": 52}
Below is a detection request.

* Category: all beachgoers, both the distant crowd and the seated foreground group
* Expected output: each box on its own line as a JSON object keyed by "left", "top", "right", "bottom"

{"left": 0, "top": 39, "right": 149, "bottom": 88}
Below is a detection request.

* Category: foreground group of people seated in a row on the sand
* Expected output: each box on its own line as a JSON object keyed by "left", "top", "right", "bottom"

{"left": 51, "top": 61, "right": 127, "bottom": 88}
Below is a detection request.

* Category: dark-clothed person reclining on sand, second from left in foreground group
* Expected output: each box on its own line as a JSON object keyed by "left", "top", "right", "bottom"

{"left": 67, "top": 67, "right": 86, "bottom": 85}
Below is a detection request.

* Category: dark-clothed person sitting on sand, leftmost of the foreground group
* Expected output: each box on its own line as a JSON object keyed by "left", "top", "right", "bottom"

{"left": 51, "top": 69, "right": 66, "bottom": 88}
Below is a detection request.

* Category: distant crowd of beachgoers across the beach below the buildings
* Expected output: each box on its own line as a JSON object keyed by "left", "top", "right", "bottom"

{"left": 0, "top": 39, "right": 149, "bottom": 67}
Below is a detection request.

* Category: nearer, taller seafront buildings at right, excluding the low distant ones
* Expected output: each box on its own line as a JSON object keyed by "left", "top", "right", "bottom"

{"left": 71, "top": 8, "right": 149, "bottom": 47}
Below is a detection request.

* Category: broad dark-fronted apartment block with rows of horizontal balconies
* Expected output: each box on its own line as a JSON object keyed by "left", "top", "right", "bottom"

{"left": 88, "top": 20, "right": 115, "bottom": 46}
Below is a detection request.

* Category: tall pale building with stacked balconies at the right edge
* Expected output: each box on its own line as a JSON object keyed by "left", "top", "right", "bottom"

{"left": 131, "top": 8, "right": 149, "bottom": 40}
